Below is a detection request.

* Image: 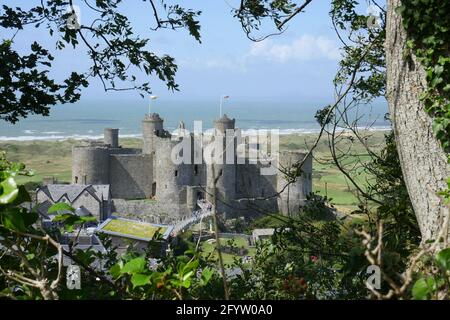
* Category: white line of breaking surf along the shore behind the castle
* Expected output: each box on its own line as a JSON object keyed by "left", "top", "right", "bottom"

{"left": 0, "top": 126, "right": 391, "bottom": 142}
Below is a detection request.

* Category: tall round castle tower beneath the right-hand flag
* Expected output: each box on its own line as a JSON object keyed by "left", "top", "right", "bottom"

{"left": 206, "top": 115, "right": 236, "bottom": 214}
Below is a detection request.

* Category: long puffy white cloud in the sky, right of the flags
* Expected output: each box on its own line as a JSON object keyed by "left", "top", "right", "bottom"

{"left": 249, "top": 35, "right": 341, "bottom": 62}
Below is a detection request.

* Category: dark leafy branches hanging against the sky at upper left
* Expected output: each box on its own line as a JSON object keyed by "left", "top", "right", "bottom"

{"left": 0, "top": 0, "right": 201, "bottom": 123}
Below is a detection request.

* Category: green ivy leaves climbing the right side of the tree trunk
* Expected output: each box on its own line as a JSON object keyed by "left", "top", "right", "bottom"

{"left": 397, "top": 0, "right": 450, "bottom": 153}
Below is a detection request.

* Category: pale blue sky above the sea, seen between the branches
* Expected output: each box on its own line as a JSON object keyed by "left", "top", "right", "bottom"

{"left": 7, "top": 0, "right": 356, "bottom": 101}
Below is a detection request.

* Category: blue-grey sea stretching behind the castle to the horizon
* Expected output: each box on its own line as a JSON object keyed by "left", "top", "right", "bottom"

{"left": 0, "top": 99, "right": 390, "bottom": 141}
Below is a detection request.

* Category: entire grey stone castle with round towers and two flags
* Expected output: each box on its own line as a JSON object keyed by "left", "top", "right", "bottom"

{"left": 72, "top": 113, "right": 312, "bottom": 222}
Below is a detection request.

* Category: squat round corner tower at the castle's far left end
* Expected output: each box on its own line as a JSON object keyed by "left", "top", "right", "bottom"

{"left": 72, "top": 143, "right": 110, "bottom": 184}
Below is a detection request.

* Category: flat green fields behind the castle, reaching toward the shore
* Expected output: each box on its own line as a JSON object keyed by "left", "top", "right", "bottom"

{"left": 0, "top": 132, "right": 384, "bottom": 212}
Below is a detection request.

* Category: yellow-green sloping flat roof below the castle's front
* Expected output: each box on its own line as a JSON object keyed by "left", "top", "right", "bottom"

{"left": 102, "top": 219, "right": 167, "bottom": 239}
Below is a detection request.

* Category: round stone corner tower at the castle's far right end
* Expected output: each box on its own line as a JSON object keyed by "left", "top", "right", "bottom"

{"left": 277, "top": 151, "right": 312, "bottom": 215}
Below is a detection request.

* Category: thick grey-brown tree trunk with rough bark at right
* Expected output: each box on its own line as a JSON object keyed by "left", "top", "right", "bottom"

{"left": 386, "top": 0, "right": 449, "bottom": 243}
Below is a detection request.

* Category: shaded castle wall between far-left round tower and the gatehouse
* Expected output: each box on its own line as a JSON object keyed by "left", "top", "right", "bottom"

{"left": 110, "top": 154, "right": 153, "bottom": 199}
